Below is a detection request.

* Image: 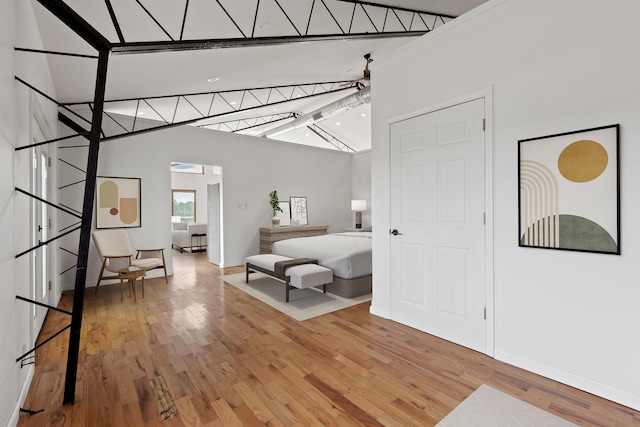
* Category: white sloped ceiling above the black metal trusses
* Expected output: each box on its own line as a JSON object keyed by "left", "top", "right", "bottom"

{"left": 30, "top": 0, "right": 486, "bottom": 151}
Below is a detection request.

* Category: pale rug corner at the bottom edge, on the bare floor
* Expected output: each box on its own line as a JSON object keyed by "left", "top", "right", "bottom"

{"left": 436, "top": 384, "right": 577, "bottom": 427}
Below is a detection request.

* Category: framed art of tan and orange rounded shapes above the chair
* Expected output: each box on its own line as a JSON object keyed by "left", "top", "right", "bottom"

{"left": 96, "top": 176, "right": 142, "bottom": 228}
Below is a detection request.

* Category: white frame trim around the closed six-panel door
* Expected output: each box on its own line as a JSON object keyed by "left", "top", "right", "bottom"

{"left": 387, "top": 86, "right": 495, "bottom": 357}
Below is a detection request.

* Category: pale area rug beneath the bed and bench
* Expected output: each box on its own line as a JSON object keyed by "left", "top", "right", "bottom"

{"left": 222, "top": 273, "right": 371, "bottom": 321}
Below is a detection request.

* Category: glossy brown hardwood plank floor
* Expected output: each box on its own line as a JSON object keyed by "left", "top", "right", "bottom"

{"left": 19, "top": 254, "right": 640, "bottom": 427}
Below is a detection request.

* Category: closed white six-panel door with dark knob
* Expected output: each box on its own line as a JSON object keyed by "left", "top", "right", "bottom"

{"left": 389, "top": 99, "right": 486, "bottom": 353}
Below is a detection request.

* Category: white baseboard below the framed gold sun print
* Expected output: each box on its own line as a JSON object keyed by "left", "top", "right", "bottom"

{"left": 495, "top": 349, "right": 640, "bottom": 411}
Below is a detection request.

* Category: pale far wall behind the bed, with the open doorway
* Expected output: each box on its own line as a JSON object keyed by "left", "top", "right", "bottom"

{"left": 60, "top": 121, "right": 352, "bottom": 288}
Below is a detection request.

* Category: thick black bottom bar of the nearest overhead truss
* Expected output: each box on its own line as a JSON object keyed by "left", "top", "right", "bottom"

{"left": 111, "top": 30, "right": 428, "bottom": 55}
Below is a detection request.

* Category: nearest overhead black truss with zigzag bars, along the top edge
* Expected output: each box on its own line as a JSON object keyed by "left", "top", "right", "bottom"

{"left": 99, "top": 0, "right": 455, "bottom": 54}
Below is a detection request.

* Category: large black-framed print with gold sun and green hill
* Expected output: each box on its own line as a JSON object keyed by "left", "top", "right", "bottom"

{"left": 518, "top": 125, "right": 620, "bottom": 255}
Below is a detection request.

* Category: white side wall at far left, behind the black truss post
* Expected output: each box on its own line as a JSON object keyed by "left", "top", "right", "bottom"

{"left": 0, "top": 0, "right": 58, "bottom": 425}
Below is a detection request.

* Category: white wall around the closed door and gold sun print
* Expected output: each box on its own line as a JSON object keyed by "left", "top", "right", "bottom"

{"left": 372, "top": 0, "right": 640, "bottom": 409}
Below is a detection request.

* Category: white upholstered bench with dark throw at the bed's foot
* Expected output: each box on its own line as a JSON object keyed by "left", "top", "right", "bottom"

{"left": 245, "top": 254, "right": 333, "bottom": 302}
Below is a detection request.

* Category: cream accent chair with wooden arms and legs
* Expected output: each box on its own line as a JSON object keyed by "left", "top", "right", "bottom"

{"left": 91, "top": 229, "right": 169, "bottom": 293}
